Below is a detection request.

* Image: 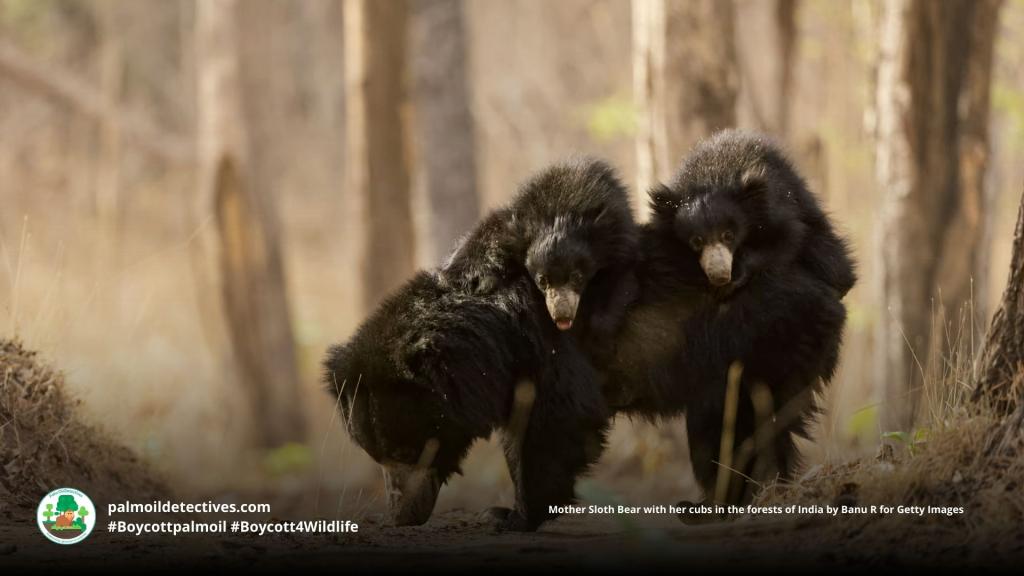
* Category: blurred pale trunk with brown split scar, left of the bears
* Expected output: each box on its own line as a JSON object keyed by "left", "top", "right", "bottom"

{"left": 196, "top": 0, "right": 304, "bottom": 448}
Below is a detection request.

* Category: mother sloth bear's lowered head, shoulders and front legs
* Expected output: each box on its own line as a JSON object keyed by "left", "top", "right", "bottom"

{"left": 325, "top": 273, "right": 608, "bottom": 530}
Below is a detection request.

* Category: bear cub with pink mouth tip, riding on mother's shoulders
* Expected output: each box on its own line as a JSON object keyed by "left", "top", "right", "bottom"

{"left": 441, "top": 158, "right": 638, "bottom": 359}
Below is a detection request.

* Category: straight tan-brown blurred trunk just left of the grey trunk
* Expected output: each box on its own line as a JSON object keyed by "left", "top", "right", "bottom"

{"left": 343, "top": 0, "right": 415, "bottom": 308}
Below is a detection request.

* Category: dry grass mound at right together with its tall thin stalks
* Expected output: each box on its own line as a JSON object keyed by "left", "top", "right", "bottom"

{"left": 756, "top": 286, "right": 1024, "bottom": 563}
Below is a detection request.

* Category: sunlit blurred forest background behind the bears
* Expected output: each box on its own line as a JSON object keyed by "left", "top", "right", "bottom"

{"left": 0, "top": 0, "right": 1024, "bottom": 510}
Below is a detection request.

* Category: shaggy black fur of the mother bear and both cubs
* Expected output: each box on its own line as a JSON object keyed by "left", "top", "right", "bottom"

{"left": 326, "top": 132, "right": 855, "bottom": 530}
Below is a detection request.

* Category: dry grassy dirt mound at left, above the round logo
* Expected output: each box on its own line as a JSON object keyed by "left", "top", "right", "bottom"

{"left": 0, "top": 339, "right": 170, "bottom": 524}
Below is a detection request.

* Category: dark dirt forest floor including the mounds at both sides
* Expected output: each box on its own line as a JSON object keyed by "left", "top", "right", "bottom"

{"left": 6, "top": 340, "right": 1024, "bottom": 574}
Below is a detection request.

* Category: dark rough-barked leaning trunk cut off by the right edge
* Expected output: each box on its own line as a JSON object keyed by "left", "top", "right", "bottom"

{"left": 974, "top": 190, "right": 1024, "bottom": 414}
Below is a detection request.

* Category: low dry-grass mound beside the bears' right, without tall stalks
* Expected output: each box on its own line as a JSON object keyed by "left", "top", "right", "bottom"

{"left": 757, "top": 372, "right": 1024, "bottom": 562}
